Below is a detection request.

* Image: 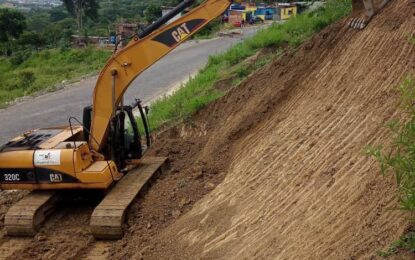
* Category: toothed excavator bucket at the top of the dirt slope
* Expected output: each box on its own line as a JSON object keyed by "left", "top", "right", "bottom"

{"left": 349, "top": 0, "right": 389, "bottom": 30}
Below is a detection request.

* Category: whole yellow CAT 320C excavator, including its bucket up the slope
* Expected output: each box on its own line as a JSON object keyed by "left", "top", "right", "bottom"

{"left": 0, "top": 0, "right": 387, "bottom": 239}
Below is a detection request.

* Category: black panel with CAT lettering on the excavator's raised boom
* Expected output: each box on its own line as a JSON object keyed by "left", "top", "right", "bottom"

{"left": 152, "top": 19, "right": 207, "bottom": 48}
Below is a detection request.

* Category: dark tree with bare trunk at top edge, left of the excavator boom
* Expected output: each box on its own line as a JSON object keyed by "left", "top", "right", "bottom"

{"left": 62, "top": 0, "right": 99, "bottom": 32}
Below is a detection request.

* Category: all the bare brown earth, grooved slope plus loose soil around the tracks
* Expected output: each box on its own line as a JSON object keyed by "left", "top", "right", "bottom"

{"left": 0, "top": 0, "right": 415, "bottom": 259}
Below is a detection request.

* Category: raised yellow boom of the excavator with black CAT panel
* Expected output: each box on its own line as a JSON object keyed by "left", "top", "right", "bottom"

{"left": 89, "top": 0, "right": 231, "bottom": 152}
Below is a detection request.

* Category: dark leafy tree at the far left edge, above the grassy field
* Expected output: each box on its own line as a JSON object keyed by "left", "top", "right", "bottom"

{"left": 0, "top": 8, "right": 26, "bottom": 56}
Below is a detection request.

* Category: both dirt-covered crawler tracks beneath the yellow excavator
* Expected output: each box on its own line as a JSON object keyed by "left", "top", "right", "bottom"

{"left": 4, "top": 157, "right": 168, "bottom": 239}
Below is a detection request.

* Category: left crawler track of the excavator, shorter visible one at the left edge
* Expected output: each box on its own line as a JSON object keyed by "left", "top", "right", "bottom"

{"left": 4, "top": 191, "right": 60, "bottom": 236}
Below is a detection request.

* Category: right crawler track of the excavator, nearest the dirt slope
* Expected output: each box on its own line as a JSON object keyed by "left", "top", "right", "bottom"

{"left": 90, "top": 157, "right": 167, "bottom": 239}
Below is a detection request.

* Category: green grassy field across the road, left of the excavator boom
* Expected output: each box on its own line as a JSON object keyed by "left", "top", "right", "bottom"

{"left": 0, "top": 48, "right": 111, "bottom": 107}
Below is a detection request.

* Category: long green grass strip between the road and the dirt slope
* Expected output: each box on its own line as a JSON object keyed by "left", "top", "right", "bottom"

{"left": 145, "top": 0, "right": 351, "bottom": 129}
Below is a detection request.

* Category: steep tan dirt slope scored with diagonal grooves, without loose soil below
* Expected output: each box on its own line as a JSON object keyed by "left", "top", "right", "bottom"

{"left": 141, "top": 1, "right": 415, "bottom": 259}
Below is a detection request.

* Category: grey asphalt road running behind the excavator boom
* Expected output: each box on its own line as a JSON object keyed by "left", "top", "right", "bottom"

{"left": 0, "top": 28, "right": 264, "bottom": 144}
